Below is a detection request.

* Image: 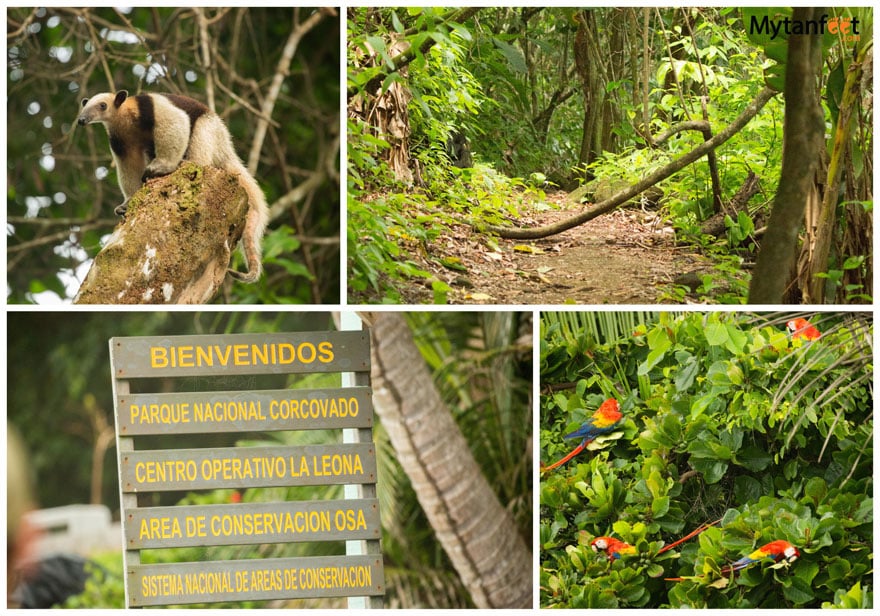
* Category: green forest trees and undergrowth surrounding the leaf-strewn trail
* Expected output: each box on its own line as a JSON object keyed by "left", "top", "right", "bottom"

{"left": 347, "top": 7, "right": 873, "bottom": 303}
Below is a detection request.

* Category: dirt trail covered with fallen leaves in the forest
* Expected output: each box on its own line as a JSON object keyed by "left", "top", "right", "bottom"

{"left": 350, "top": 188, "right": 709, "bottom": 305}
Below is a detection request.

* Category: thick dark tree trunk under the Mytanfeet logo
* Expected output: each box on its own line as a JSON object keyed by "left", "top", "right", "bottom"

{"left": 749, "top": 7, "right": 825, "bottom": 304}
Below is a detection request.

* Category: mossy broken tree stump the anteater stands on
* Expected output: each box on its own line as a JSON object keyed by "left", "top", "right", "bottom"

{"left": 74, "top": 163, "right": 248, "bottom": 304}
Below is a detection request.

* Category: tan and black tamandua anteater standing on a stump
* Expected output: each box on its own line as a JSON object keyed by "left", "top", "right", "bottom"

{"left": 78, "top": 90, "right": 269, "bottom": 282}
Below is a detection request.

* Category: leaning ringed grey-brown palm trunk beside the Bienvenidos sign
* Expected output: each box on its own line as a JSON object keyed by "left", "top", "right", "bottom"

{"left": 361, "top": 312, "right": 532, "bottom": 609}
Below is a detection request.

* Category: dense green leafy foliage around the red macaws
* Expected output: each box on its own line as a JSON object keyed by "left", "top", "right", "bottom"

{"left": 539, "top": 313, "right": 873, "bottom": 609}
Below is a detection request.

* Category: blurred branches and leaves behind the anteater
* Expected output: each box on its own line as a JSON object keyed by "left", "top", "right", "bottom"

{"left": 7, "top": 7, "right": 340, "bottom": 303}
